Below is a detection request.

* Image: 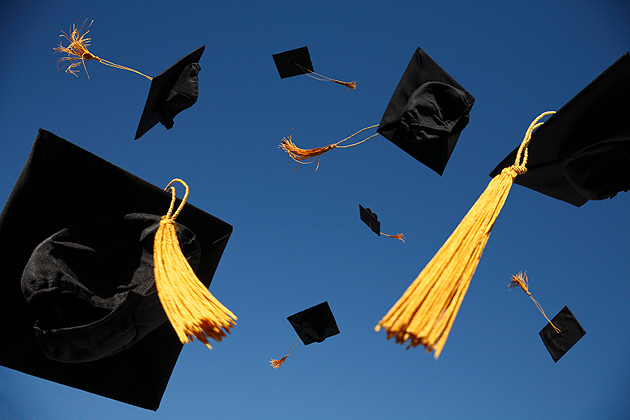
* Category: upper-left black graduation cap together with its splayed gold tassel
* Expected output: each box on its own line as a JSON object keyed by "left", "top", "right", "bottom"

{"left": 54, "top": 20, "right": 205, "bottom": 140}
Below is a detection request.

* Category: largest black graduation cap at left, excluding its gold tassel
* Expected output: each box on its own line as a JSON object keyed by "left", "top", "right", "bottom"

{"left": 0, "top": 130, "right": 232, "bottom": 410}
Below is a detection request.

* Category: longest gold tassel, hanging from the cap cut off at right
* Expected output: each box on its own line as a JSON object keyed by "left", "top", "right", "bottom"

{"left": 374, "top": 111, "right": 553, "bottom": 359}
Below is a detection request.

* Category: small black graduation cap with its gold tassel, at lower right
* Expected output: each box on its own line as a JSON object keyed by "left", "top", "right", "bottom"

{"left": 508, "top": 273, "right": 586, "bottom": 362}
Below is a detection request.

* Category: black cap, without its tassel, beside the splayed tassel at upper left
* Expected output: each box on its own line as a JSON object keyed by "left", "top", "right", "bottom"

{"left": 135, "top": 45, "right": 206, "bottom": 140}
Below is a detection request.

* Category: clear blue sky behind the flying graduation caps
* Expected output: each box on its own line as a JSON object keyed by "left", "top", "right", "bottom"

{"left": 0, "top": 0, "right": 630, "bottom": 420}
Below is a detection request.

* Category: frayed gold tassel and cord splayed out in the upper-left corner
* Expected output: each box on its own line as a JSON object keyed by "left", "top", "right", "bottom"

{"left": 53, "top": 19, "right": 153, "bottom": 80}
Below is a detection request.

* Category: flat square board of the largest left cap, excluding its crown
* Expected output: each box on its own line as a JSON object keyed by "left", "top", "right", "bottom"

{"left": 0, "top": 130, "right": 232, "bottom": 410}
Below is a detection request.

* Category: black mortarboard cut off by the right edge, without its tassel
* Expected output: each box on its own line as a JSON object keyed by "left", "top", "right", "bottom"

{"left": 490, "top": 52, "right": 630, "bottom": 207}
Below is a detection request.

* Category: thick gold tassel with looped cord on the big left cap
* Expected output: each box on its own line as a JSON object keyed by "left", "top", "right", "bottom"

{"left": 153, "top": 179, "right": 237, "bottom": 349}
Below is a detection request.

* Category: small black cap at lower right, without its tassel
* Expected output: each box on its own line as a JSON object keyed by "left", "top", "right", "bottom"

{"left": 539, "top": 306, "right": 586, "bottom": 362}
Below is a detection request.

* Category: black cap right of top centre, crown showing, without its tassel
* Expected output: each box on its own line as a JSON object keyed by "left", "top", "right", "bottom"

{"left": 377, "top": 47, "right": 475, "bottom": 175}
